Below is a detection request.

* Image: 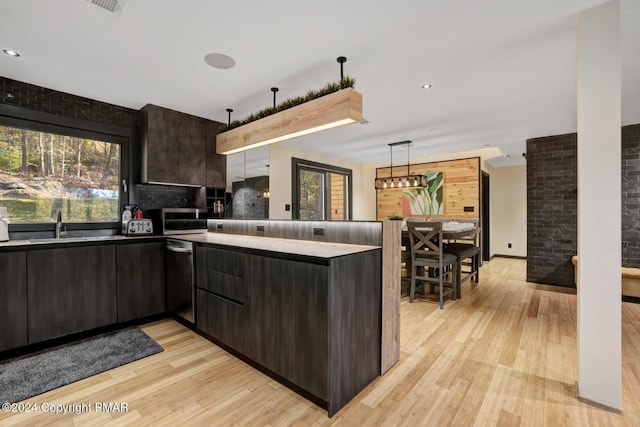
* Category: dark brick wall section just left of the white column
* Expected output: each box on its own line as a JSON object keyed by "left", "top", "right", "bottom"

{"left": 527, "top": 133, "right": 578, "bottom": 287}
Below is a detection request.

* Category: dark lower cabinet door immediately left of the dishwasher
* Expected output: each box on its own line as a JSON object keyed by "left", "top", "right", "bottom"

{"left": 116, "top": 242, "right": 166, "bottom": 322}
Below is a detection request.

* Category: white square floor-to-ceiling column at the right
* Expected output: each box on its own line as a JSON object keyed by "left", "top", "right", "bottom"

{"left": 567, "top": 0, "right": 622, "bottom": 411}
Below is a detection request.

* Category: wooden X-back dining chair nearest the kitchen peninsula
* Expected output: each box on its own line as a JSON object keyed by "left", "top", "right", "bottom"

{"left": 407, "top": 221, "right": 458, "bottom": 309}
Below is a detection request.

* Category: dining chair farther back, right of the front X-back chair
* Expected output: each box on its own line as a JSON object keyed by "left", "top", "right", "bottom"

{"left": 444, "top": 219, "right": 480, "bottom": 298}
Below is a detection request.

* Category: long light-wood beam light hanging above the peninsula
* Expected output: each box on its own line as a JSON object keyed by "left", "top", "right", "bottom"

{"left": 216, "top": 57, "right": 362, "bottom": 155}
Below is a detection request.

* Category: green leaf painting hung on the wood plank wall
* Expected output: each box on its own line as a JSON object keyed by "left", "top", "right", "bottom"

{"left": 402, "top": 172, "right": 444, "bottom": 216}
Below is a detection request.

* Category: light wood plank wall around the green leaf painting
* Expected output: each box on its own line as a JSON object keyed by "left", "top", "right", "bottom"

{"left": 376, "top": 157, "right": 481, "bottom": 220}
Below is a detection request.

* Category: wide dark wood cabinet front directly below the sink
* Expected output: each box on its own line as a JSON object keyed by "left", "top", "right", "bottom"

{"left": 27, "top": 245, "right": 117, "bottom": 343}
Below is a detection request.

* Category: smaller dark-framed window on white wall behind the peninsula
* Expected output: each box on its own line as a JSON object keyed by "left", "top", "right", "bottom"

{"left": 292, "top": 158, "right": 352, "bottom": 221}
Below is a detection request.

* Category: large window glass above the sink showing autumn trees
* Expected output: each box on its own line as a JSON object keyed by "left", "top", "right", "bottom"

{"left": 0, "top": 120, "right": 123, "bottom": 224}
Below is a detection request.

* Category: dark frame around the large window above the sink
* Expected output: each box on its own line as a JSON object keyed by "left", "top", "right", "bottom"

{"left": 0, "top": 104, "right": 134, "bottom": 233}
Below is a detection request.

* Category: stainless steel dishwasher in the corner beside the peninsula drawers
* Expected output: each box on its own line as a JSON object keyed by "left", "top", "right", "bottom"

{"left": 165, "top": 239, "right": 195, "bottom": 323}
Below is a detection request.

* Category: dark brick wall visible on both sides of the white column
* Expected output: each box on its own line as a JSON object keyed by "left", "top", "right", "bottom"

{"left": 527, "top": 124, "right": 640, "bottom": 287}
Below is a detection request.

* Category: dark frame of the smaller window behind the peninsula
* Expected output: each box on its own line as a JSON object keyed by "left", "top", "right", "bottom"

{"left": 291, "top": 157, "right": 353, "bottom": 221}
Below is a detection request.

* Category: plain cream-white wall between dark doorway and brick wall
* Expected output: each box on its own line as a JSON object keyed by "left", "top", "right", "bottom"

{"left": 484, "top": 165, "right": 527, "bottom": 257}
